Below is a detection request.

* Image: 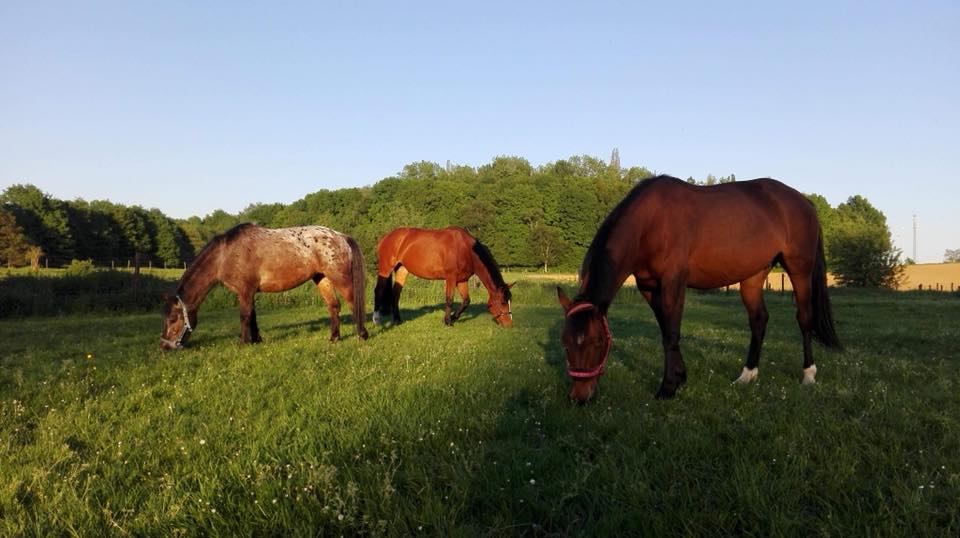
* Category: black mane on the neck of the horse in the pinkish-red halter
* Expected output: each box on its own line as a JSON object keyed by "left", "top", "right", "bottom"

{"left": 575, "top": 175, "right": 680, "bottom": 304}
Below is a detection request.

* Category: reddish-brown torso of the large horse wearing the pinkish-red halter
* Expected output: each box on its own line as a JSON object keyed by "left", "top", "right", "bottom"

{"left": 611, "top": 178, "right": 819, "bottom": 288}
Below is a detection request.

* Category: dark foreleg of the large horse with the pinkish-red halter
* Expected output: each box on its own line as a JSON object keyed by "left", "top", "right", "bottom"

{"left": 650, "top": 280, "right": 687, "bottom": 400}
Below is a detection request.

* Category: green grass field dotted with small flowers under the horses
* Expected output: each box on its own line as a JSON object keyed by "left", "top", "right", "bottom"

{"left": 0, "top": 281, "right": 960, "bottom": 536}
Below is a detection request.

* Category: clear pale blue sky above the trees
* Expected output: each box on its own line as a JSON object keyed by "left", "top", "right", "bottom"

{"left": 0, "top": 0, "right": 960, "bottom": 262}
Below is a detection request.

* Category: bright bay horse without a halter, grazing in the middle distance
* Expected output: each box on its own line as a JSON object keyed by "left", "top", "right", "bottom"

{"left": 373, "top": 226, "right": 513, "bottom": 327}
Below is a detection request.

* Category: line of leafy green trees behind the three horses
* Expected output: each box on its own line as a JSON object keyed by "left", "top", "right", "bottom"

{"left": 0, "top": 155, "right": 899, "bottom": 286}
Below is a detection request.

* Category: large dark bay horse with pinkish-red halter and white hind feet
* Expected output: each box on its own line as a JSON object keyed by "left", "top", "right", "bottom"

{"left": 557, "top": 176, "right": 840, "bottom": 403}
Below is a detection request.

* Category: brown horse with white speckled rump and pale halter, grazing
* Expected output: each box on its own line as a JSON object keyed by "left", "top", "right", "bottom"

{"left": 160, "top": 223, "right": 367, "bottom": 349}
